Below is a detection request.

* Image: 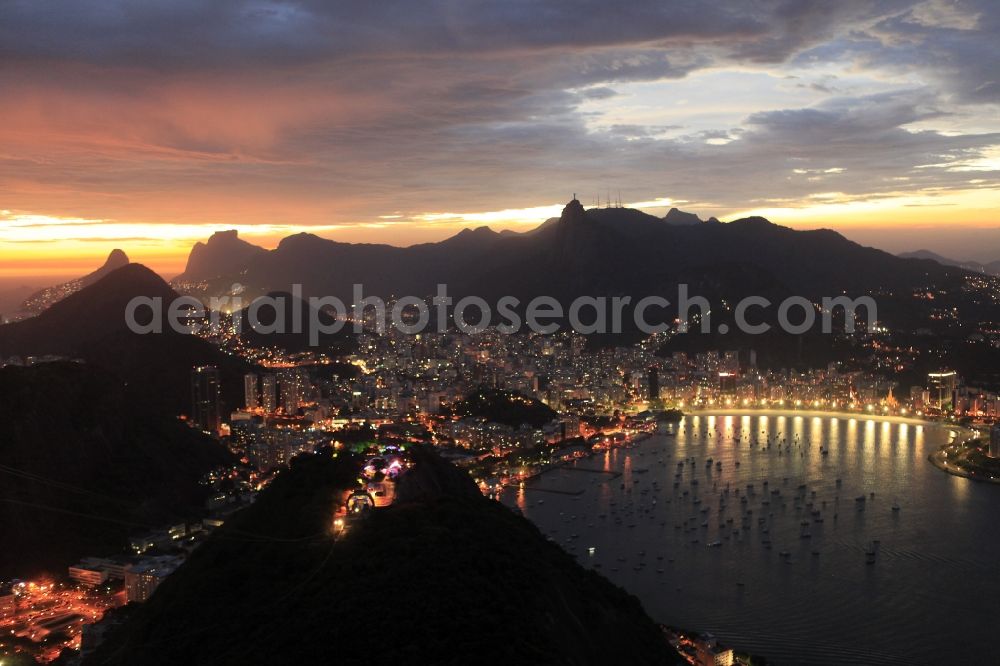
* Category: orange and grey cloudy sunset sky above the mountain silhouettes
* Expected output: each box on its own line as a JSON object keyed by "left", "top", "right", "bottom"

{"left": 0, "top": 0, "right": 1000, "bottom": 279}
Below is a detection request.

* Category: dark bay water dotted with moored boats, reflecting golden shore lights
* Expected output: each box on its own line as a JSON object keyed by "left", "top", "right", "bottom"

{"left": 504, "top": 415, "right": 1000, "bottom": 664}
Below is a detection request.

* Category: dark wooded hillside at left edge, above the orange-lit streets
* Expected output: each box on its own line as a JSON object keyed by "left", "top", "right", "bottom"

{"left": 0, "top": 363, "right": 231, "bottom": 580}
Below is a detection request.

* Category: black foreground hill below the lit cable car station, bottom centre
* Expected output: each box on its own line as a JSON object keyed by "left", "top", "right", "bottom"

{"left": 86, "top": 453, "right": 678, "bottom": 666}
